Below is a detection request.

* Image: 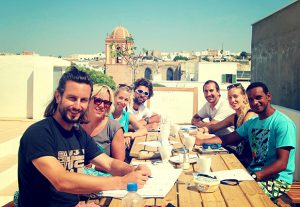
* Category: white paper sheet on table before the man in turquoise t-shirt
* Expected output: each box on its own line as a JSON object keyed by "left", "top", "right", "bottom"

{"left": 209, "top": 169, "right": 254, "bottom": 181}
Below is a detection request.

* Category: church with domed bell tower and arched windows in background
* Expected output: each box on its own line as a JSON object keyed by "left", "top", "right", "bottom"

{"left": 105, "top": 26, "right": 181, "bottom": 84}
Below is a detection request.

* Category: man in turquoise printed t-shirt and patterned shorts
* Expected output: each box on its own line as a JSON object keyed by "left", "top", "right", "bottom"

{"left": 196, "top": 82, "right": 296, "bottom": 201}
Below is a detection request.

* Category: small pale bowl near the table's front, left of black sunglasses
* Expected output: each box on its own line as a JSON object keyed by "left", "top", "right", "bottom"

{"left": 193, "top": 173, "right": 220, "bottom": 193}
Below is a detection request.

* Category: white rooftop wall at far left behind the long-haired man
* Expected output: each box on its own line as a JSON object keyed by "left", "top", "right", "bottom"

{"left": 0, "top": 55, "right": 70, "bottom": 119}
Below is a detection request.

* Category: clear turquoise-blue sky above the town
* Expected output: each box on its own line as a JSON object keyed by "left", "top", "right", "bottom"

{"left": 0, "top": 0, "right": 293, "bottom": 55}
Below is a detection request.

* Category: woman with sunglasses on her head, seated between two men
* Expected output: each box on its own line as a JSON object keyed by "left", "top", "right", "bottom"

{"left": 196, "top": 83, "right": 257, "bottom": 165}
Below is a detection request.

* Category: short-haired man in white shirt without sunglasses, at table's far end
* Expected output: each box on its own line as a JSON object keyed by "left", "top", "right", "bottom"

{"left": 192, "top": 80, "right": 235, "bottom": 135}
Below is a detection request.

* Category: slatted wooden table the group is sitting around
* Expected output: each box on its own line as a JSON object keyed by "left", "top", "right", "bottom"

{"left": 89, "top": 132, "right": 275, "bottom": 207}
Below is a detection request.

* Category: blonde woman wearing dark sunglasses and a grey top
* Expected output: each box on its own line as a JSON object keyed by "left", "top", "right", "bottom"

{"left": 82, "top": 85, "right": 125, "bottom": 161}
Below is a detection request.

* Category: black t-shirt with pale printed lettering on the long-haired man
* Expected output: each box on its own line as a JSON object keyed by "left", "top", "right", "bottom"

{"left": 18, "top": 117, "right": 101, "bottom": 207}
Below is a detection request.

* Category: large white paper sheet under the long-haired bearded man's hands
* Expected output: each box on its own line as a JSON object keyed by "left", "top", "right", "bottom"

{"left": 102, "top": 162, "right": 182, "bottom": 198}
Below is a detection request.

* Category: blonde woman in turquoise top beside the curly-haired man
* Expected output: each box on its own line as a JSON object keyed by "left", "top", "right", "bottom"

{"left": 109, "top": 84, "right": 148, "bottom": 146}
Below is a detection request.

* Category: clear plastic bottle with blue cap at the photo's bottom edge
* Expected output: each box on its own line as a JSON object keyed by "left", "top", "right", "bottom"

{"left": 122, "top": 183, "right": 145, "bottom": 207}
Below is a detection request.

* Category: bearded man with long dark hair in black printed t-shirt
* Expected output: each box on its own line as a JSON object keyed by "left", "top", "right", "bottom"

{"left": 18, "top": 68, "right": 151, "bottom": 207}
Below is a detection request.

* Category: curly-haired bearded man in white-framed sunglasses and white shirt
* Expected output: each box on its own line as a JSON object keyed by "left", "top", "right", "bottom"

{"left": 130, "top": 78, "right": 159, "bottom": 129}
